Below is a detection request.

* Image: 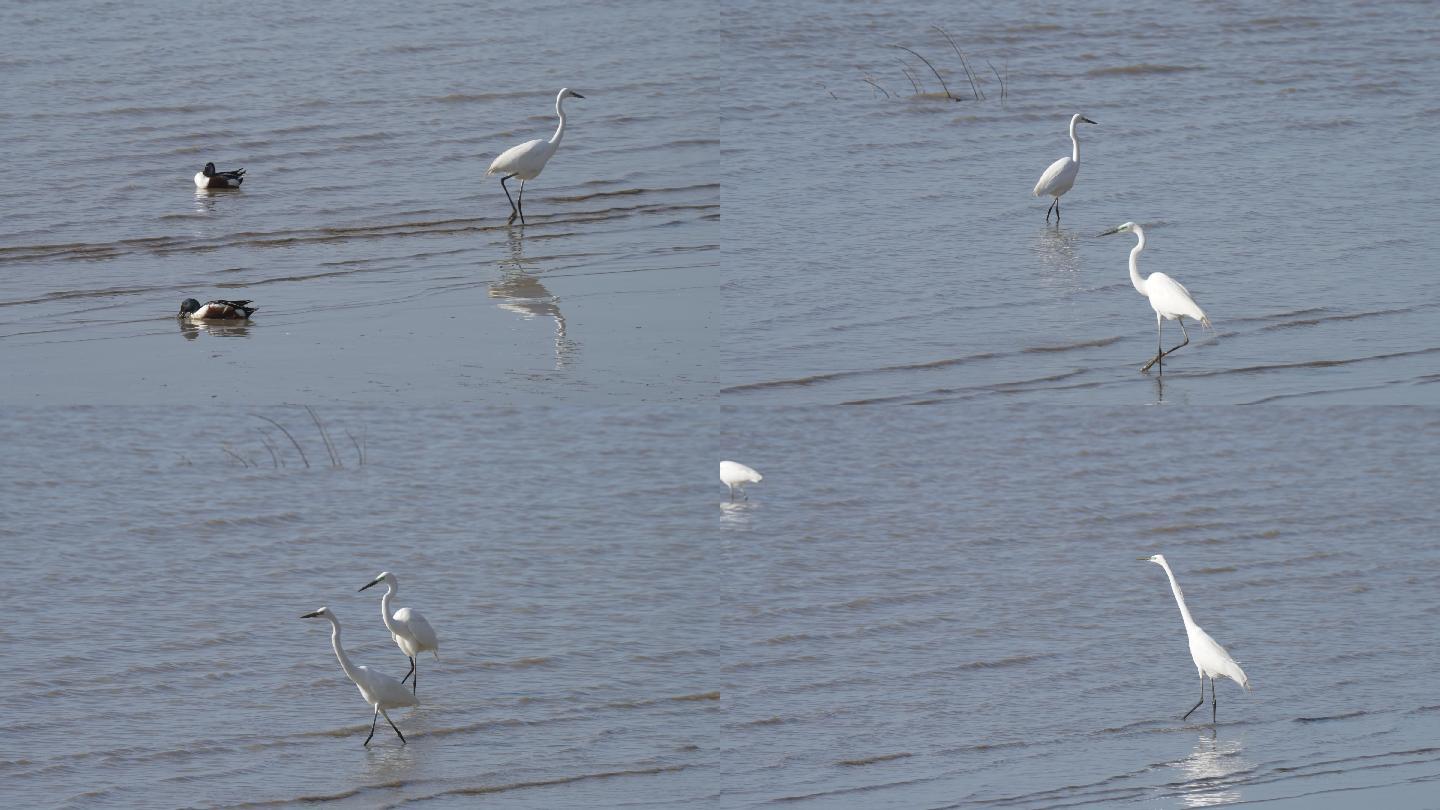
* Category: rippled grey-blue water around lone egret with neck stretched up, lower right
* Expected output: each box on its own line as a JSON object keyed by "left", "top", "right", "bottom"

{"left": 719, "top": 405, "right": 1440, "bottom": 809}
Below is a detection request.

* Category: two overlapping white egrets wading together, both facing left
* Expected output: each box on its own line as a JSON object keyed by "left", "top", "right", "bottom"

{"left": 301, "top": 571, "right": 441, "bottom": 745}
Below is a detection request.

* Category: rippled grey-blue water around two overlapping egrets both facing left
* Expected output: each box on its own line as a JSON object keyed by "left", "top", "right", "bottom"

{"left": 0, "top": 408, "right": 721, "bottom": 807}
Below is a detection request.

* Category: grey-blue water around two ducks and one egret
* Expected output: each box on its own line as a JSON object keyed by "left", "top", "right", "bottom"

{"left": 0, "top": 1, "right": 720, "bottom": 404}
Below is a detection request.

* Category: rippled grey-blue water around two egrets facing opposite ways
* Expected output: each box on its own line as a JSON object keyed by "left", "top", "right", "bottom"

{"left": 721, "top": 0, "right": 1440, "bottom": 406}
